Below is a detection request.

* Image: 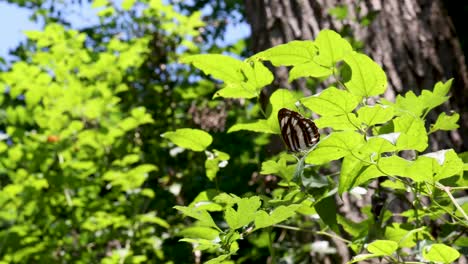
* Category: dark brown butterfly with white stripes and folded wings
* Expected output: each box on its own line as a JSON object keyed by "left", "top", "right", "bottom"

{"left": 278, "top": 108, "right": 320, "bottom": 152}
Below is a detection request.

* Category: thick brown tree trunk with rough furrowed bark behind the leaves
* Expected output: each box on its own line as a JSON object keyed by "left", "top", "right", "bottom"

{"left": 245, "top": 0, "right": 468, "bottom": 151}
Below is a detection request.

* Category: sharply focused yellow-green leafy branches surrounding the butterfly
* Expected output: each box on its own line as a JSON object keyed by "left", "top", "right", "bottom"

{"left": 178, "top": 27, "right": 468, "bottom": 263}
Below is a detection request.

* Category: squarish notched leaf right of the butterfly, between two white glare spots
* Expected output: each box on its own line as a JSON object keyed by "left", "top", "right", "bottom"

{"left": 393, "top": 114, "right": 428, "bottom": 151}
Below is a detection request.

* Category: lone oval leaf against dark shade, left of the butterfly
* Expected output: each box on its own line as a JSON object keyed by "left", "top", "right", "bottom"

{"left": 161, "top": 128, "right": 213, "bottom": 151}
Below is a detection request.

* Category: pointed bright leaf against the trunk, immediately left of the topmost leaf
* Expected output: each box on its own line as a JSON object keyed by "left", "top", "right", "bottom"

{"left": 250, "top": 40, "right": 317, "bottom": 66}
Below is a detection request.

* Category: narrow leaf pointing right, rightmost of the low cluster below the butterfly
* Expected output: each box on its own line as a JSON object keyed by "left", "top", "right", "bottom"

{"left": 254, "top": 204, "right": 301, "bottom": 230}
